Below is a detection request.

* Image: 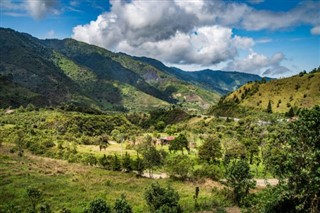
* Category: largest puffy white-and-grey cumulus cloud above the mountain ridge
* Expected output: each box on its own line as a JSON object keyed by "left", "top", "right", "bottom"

{"left": 73, "top": 0, "right": 254, "bottom": 65}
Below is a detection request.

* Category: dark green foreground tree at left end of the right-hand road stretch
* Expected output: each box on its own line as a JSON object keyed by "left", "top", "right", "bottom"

{"left": 227, "top": 160, "right": 256, "bottom": 205}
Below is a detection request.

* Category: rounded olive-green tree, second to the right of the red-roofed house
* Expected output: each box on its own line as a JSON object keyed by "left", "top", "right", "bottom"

{"left": 198, "top": 137, "right": 222, "bottom": 163}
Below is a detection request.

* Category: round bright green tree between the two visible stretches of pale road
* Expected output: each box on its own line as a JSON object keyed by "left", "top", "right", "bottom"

{"left": 166, "top": 155, "right": 193, "bottom": 180}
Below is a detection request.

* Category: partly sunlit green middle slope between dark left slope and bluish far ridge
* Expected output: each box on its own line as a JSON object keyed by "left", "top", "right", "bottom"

{"left": 43, "top": 39, "right": 219, "bottom": 110}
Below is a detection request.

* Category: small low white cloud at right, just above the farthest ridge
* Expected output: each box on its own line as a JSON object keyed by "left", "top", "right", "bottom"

{"left": 224, "top": 50, "right": 290, "bottom": 76}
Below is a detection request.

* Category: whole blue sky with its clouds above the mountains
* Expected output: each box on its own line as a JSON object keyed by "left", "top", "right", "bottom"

{"left": 0, "top": 0, "right": 320, "bottom": 78}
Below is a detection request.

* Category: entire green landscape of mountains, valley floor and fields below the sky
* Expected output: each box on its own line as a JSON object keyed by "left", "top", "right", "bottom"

{"left": 0, "top": 28, "right": 320, "bottom": 213}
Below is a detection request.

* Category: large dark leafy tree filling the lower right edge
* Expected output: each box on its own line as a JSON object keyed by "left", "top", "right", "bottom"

{"left": 279, "top": 106, "right": 320, "bottom": 212}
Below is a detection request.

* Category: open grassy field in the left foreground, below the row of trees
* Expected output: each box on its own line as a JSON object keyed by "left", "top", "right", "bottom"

{"left": 0, "top": 144, "right": 230, "bottom": 212}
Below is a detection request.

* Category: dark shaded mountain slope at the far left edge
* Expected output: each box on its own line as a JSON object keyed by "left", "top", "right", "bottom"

{"left": 0, "top": 28, "right": 99, "bottom": 110}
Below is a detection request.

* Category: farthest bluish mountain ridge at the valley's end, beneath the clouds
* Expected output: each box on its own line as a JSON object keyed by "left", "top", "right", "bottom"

{"left": 135, "top": 57, "right": 271, "bottom": 95}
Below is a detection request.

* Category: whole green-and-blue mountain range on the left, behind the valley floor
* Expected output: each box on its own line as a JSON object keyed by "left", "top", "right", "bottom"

{"left": 0, "top": 28, "right": 268, "bottom": 111}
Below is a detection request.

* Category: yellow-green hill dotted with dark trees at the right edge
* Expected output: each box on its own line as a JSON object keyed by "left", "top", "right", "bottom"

{"left": 220, "top": 68, "right": 320, "bottom": 113}
